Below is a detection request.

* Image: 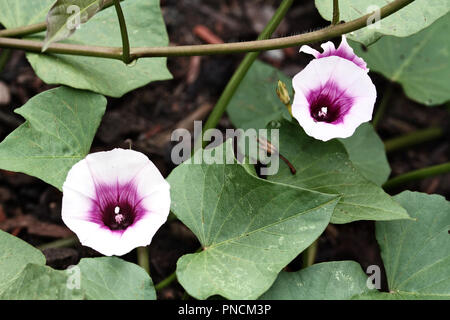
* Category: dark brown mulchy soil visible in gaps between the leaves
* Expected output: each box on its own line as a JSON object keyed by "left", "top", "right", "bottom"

{"left": 0, "top": 0, "right": 450, "bottom": 299}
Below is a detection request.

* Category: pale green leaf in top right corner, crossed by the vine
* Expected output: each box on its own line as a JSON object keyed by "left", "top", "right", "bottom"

{"left": 316, "top": 0, "right": 450, "bottom": 46}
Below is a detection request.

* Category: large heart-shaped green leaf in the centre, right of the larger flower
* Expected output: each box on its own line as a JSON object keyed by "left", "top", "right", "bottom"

{"left": 168, "top": 142, "right": 337, "bottom": 299}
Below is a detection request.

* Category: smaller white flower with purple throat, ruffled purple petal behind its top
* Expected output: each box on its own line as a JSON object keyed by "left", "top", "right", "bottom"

{"left": 292, "top": 36, "right": 377, "bottom": 141}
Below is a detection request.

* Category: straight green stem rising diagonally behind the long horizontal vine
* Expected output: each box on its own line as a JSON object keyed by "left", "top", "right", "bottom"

{"left": 194, "top": 0, "right": 294, "bottom": 151}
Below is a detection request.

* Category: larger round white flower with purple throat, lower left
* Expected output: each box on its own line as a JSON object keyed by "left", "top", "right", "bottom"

{"left": 62, "top": 149, "right": 170, "bottom": 256}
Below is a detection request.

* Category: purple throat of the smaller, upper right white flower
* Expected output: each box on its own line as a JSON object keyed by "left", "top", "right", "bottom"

{"left": 306, "top": 81, "right": 353, "bottom": 124}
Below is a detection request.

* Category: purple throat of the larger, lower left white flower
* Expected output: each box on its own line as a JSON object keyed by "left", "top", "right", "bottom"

{"left": 90, "top": 182, "right": 145, "bottom": 232}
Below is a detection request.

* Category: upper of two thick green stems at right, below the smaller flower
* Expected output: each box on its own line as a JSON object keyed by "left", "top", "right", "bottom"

{"left": 384, "top": 127, "right": 444, "bottom": 152}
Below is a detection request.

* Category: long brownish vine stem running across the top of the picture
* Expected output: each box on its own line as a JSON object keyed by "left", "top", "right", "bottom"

{"left": 0, "top": 0, "right": 414, "bottom": 60}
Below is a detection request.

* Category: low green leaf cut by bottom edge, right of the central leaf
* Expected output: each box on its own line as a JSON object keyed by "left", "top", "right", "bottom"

{"left": 260, "top": 261, "right": 378, "bottom": 300}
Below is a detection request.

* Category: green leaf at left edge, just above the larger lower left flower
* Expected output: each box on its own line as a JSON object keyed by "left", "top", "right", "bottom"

{"left": 0, "top": 87, "right": 106, "bottom": 189}
